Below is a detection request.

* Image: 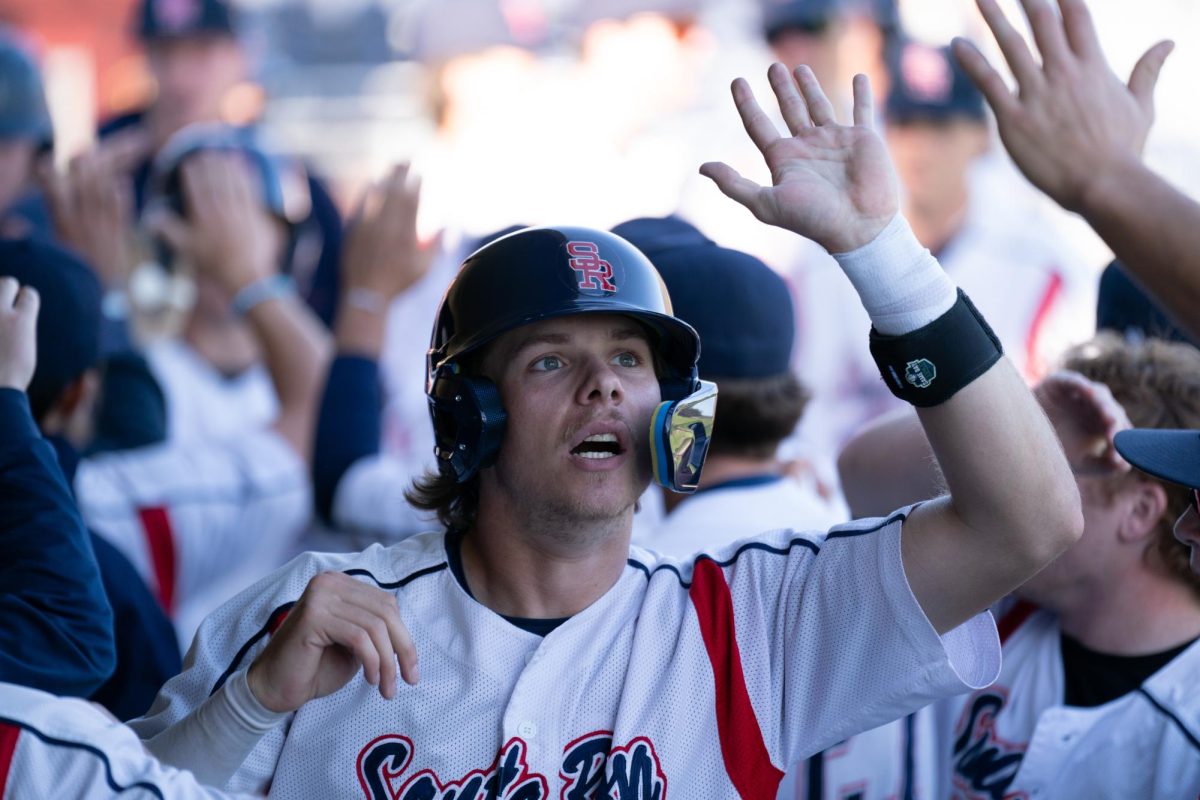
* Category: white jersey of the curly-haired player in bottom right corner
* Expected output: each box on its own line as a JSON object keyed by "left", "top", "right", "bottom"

{"left": 940, "top": 603, "right": 1200, "bottom": 800}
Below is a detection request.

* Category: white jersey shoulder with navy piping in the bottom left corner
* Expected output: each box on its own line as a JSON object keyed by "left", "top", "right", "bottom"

{"left": 0, "top": 684, "right": 248, "bottom": 800}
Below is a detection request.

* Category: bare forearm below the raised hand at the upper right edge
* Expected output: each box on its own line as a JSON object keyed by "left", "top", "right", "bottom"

{"left": 1079, "top": 161, "right": 1200, "bottom": 336}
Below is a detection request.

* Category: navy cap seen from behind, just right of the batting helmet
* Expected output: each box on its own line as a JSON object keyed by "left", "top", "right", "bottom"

{"left": 612, "top": 216, "right": 796, "bottom": 379}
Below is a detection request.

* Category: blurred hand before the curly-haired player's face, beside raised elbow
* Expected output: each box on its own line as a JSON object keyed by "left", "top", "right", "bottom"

{"left": 1033, "top": 369, "right": 1133, "bottom": 475}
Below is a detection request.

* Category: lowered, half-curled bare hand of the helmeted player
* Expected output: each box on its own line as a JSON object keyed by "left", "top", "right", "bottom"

{"left": 246, "top": 572, "right": 419, "bottom": 711}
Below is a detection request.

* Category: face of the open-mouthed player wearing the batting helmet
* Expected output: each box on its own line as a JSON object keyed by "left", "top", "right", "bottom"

{"left": 482, "top": 314, "right": 660, "bottom": 522}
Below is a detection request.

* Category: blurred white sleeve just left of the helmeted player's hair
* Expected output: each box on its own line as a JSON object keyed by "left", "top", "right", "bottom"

{"left": 334, "top": 453, "right": 437, "bottom": 545}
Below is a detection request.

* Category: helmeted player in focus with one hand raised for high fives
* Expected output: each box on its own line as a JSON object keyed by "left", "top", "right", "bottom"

{"left": 136, "top": 65, "right": 1080, "bottom": 798}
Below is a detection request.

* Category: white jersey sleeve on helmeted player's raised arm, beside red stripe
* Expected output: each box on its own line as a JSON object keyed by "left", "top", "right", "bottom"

{"left": 720, "top": 512, "right": 1000, "bottom": 765}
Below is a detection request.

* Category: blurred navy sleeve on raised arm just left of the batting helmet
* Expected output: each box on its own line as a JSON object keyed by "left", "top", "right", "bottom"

{"left": 312, "top": 355, "right": 383, "bottom": 523}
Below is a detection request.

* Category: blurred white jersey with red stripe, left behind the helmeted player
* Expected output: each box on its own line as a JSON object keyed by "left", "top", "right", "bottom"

{"left": 74, "top": 429, "right": 312, "bottom": 649}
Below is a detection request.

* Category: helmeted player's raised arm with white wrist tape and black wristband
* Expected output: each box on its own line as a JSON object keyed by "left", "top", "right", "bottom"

{"left": 701, "top": 64, "right": 1082, "bottom": 631}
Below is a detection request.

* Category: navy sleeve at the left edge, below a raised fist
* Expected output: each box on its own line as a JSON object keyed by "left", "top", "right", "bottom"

{"left": 0, "top": 389, "right": 116, "bottom": 697}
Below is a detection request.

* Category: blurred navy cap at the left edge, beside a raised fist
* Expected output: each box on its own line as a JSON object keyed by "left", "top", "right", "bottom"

{"left": 0, "top": 237, "right": 102, "bottom": 417}
